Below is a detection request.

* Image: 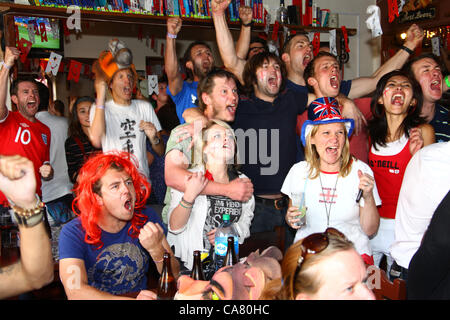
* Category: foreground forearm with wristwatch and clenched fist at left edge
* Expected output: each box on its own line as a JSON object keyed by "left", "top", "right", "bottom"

{"left": 0, "top": 155, "right": 53, "bottom": 299}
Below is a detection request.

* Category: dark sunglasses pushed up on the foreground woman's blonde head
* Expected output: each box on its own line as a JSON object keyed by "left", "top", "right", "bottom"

{"left": 292, "top": 228, "right": 347, "bottom": 283}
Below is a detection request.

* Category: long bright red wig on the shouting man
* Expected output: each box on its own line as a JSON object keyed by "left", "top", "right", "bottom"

{"left": 72, "top": 152, "right": 151, "bottom": 249}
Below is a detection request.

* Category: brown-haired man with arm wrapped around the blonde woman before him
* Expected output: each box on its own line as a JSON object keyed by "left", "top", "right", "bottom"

{"left": 162, "top": 69, "right": 253, "bottom": 223}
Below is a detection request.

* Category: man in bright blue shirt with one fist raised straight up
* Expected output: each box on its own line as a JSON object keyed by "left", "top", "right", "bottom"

{"left": 164, "top": 17, "right": 214, "bottom": 124}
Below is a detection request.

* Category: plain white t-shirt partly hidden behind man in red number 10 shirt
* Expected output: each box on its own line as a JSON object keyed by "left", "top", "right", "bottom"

{"left": 36, "top": 111, "right": 72, "bottom": 202}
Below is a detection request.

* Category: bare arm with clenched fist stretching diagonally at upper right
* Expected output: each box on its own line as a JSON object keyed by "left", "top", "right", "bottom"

{"left": 348, "top": 24, "right": 423, "bottom": 99}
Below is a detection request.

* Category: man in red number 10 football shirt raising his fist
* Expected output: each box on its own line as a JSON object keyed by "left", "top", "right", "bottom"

{"left": 0, "top": 47, "right": 53, "bottom": 215}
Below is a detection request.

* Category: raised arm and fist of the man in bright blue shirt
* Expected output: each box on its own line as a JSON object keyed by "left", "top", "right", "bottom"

{"left": 164, "top": 17, "right": 183, "bottom": 96}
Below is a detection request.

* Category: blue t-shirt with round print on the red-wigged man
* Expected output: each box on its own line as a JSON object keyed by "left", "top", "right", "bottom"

{"left": 59, "top": 208, "right": 167, "bottom": 295}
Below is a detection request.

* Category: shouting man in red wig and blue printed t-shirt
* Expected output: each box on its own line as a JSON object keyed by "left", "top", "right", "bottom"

{"left": 59, "top": 152, "right": 179, "bottom": 300}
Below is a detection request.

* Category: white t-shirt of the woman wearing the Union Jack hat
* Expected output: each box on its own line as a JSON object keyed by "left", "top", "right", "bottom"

{"left": 281, "top": 159, "right": 381, "bottom": 256}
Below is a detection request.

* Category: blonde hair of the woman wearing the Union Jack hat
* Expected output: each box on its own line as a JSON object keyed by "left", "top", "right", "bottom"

{"left": 305, "top": 124, "right": 353, "bottom": 179}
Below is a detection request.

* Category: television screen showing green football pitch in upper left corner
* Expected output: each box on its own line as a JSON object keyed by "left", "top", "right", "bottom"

{"left": 14, "top": 17, "right": 63, "bottom": 51}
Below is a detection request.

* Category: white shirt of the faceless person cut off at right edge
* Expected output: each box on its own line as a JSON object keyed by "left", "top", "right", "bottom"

{"left": 391, "top": 141, "right": 450, "bottom": 269}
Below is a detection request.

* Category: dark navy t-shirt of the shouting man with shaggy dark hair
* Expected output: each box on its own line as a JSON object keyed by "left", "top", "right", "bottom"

{"left": 232, "top": 89, "right": 308, "bottom": 195}
